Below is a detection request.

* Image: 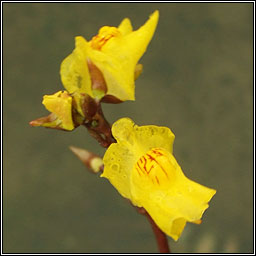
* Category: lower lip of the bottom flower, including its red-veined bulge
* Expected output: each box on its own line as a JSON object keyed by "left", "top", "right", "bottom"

{"left": 131, "top": 149, "right": 216, "bottom": 240}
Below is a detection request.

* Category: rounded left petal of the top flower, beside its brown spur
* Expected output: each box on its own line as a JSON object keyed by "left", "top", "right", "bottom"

{"left": 60, "top": 36, "right": 92, "bottom": 96}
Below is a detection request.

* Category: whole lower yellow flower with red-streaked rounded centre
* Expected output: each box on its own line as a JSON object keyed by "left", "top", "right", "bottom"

{"left": 101, "top": 118, "right": 216, "bottom": 240}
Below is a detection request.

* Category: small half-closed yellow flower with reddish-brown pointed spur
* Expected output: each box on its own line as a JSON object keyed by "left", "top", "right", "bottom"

{"left": 30, "top": 91, "right": 75, "bottom": 131}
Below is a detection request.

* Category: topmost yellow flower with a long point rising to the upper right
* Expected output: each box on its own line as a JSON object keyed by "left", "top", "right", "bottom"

{"left": 60, "top": 11, "right": 159, "bottom": 101}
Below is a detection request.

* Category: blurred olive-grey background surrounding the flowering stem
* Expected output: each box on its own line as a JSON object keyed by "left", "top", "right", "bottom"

{"left": 3, "top": 3, "right": 254, "bottom": 253}
